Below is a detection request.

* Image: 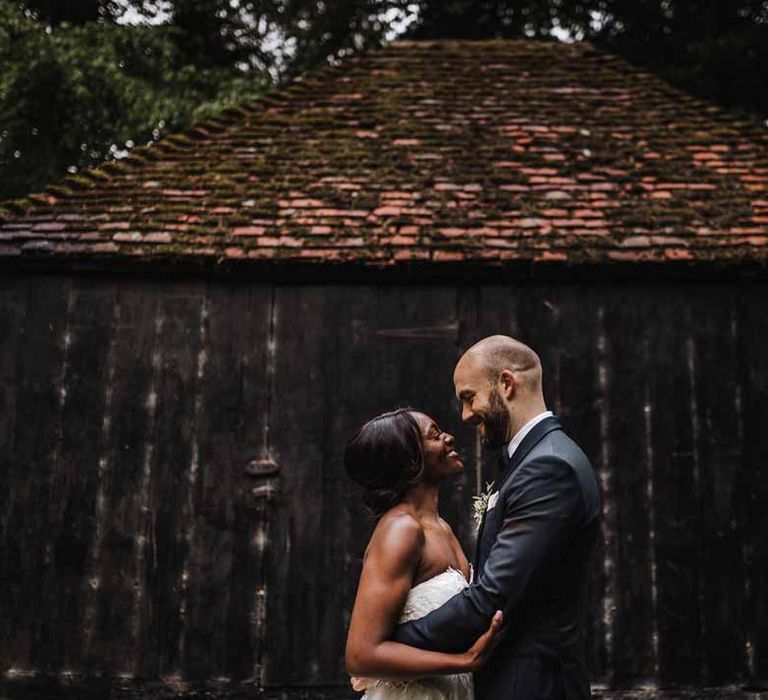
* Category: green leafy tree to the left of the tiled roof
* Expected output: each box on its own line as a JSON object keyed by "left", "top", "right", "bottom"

{"left": 0, "top": 2, "right": 266, "bottom": 197}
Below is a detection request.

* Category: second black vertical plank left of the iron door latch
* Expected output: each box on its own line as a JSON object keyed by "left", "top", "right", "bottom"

{"left": 136, "top": 283, "right": 205, "bottom": 678}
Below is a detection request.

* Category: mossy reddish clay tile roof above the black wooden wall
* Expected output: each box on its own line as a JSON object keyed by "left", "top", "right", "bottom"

{"left": 0, "top": 41, "right": 768, "bottom": 265}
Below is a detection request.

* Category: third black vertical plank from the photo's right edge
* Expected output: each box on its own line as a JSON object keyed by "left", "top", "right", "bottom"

{"left": 648, "top": 287, "right": 702, "bottom": 685}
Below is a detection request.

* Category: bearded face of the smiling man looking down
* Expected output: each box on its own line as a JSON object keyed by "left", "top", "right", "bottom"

{"left": 453, "top": 360, "right": 509, "bottom": 447}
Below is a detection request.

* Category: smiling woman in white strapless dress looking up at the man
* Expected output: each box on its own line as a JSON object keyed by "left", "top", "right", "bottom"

{"left": 344, "top": 409, "right": 501, "bottom": 700}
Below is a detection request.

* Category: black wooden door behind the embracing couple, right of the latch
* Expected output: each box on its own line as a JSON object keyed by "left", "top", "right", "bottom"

{"left": 266, "top": 286, "right": 474, "bottom": 697}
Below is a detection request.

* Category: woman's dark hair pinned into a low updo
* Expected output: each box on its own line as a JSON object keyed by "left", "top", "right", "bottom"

{"left": 344, "top": 408, "right": 424, "bottom": 518}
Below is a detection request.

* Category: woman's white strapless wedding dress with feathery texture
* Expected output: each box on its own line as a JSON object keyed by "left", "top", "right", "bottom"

{"left": 352, "top": 567, "right": 474, "bottom": 700}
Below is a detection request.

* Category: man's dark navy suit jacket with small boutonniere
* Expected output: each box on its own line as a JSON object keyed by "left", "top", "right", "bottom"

{"left": 395, "top": 417, "right": 601, "bottom": 700}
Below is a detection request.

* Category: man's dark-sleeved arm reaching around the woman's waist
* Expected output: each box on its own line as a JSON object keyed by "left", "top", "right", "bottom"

{"left": 395, "top": 457, "right": 581, "bottom": 652}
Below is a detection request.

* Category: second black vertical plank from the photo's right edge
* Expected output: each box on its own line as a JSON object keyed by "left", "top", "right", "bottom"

{"left": 689, "top": 288, "right": 746, "bottom": 685}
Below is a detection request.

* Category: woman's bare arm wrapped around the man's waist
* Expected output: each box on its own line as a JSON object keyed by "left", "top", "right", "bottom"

{"left": 346, "top": 514, "right": 501, "bottom": 680}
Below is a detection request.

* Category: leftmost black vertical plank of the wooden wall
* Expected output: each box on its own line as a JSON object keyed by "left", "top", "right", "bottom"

{"left": 3, "top": 278, "right": 72, "bottom": 671}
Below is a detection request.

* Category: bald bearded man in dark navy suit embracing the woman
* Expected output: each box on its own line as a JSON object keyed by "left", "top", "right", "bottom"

{"left": 395, "top": 335, "right": 600, "bottom": 700}
